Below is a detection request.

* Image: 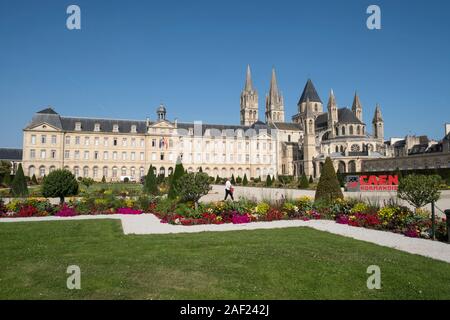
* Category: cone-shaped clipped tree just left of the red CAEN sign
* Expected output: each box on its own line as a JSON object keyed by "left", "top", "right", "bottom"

{"left": 315, "top": 157, "right": 344, "bottom": 201}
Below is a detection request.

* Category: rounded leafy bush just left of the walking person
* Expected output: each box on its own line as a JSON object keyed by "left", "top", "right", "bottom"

{"left": 175, "top": 172, "right": 211, "bottom": 205}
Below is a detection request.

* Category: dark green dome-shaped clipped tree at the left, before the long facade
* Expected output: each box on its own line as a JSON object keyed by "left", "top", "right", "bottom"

{"left": 42, "top": 169, "right": 79, "bottom": 204}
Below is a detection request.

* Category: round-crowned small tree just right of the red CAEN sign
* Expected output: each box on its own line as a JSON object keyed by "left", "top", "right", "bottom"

{"left": 397, "top": 174, "right": 441, "bottom": 209}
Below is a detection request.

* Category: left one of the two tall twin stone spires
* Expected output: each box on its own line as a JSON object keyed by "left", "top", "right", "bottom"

{"left": 241, "top": 66, "right": 258, "bottom": 126}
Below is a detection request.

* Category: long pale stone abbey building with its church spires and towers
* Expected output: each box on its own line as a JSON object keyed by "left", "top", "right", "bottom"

{"left": 23, "top": 67, "right": 388, "bottom": 181}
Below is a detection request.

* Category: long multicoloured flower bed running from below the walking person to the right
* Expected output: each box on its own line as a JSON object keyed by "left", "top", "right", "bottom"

{"left": 153, "top": 197, "right": 446, "bottom": 241}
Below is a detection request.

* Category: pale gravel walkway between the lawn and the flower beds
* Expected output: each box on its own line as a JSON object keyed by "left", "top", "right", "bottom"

{"left": 0, "top": 214, "right": 450, "bottom": 263}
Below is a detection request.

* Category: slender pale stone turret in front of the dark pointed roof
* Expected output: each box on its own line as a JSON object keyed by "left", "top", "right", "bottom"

{"left": 303, "top": 97, "right": 317, "bottom": 177}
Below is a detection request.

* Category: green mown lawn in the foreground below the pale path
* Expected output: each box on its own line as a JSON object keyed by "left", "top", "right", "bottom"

{"left": 0, "top": 220, "right": 450, "bottom": 299}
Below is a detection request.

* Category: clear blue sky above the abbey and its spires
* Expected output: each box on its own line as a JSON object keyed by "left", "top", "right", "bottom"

{"left": 0, "top": 0, "right": 450, "bottom": 147}
